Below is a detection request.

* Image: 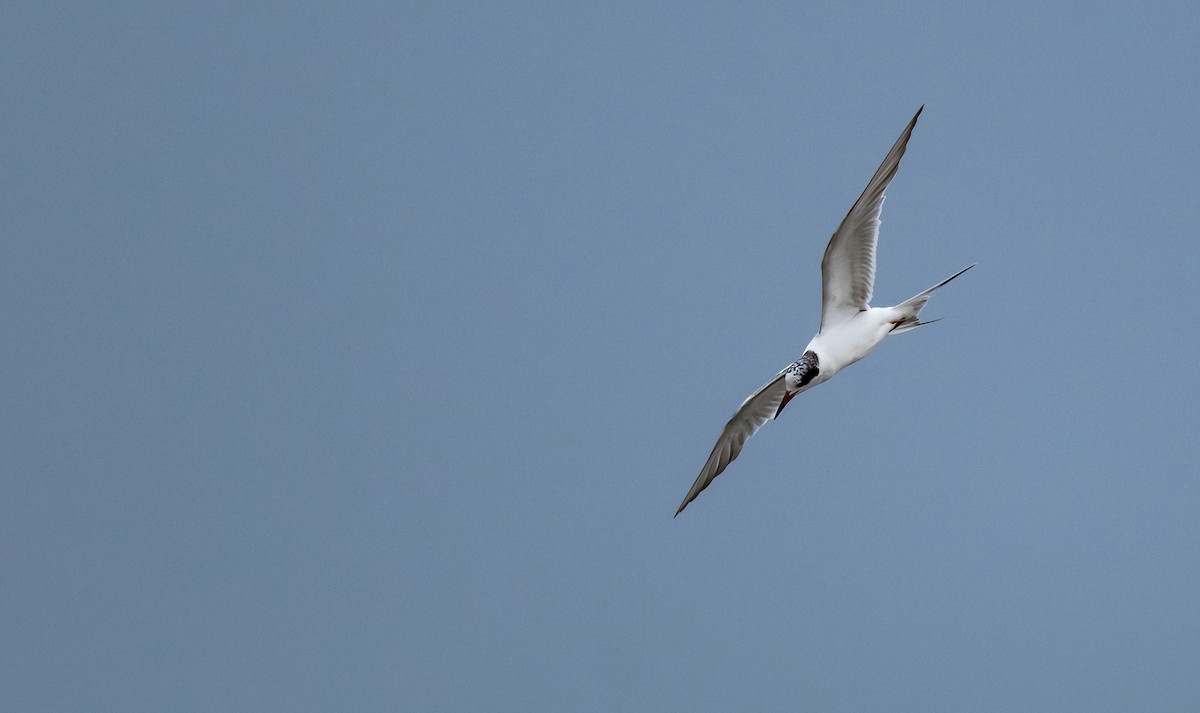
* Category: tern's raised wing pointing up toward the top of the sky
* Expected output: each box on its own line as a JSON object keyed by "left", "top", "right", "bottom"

{"left": 821, "top": 106, "right": 925, "bottom": 331}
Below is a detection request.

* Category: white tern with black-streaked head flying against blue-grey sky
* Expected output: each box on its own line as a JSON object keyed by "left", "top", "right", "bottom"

{"left": 676, "top": 106, "right": 974, "bottom": 516}
